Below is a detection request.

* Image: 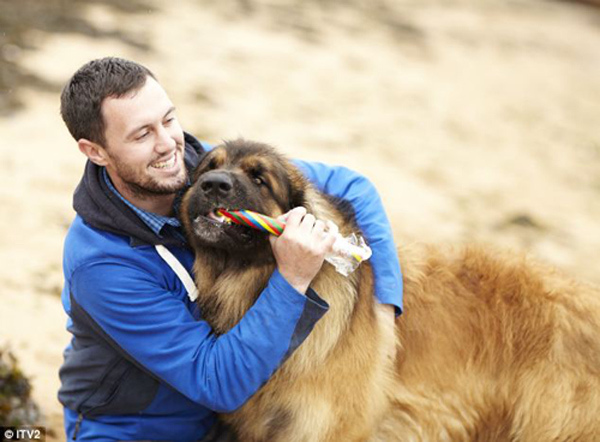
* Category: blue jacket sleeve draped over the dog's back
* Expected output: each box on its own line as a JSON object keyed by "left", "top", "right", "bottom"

{"left": 294, "top": 160, "right": 403, "bottom": 316}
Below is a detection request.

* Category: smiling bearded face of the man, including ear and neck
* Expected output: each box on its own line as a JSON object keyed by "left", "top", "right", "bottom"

{"left": 78, "top": 76, "right": 187, "bottom": 215}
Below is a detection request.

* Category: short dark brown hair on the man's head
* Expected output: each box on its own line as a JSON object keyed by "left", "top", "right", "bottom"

{"left": 60, "top": 57, "right": 156, "bottom": 146}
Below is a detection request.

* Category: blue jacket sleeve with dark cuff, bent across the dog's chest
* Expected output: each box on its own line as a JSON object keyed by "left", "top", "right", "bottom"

{"left": 70, "top": 260, "right": 328, "bottom": 412}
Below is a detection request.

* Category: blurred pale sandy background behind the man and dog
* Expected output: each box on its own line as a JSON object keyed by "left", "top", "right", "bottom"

{"left": 0, "top": 0, "right": 600, "bottom": 440}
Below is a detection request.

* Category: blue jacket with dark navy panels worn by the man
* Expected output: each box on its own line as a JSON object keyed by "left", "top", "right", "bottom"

{"left": 59, "top": 134, "right": 402, "bottom": 441}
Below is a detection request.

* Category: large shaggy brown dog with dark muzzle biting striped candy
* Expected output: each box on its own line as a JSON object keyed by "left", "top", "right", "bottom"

{"left": 181, "top": 140, "right": 600, "bottom": 442}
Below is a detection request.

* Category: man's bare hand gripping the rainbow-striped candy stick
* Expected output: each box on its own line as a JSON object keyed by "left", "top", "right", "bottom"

{"left": 269, "top": 207, "right": 336, "bottom": 293}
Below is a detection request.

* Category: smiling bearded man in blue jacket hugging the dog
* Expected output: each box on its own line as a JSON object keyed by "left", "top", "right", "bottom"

{"left": 59, "top": 58, "right": 402, "bottom": 441}
